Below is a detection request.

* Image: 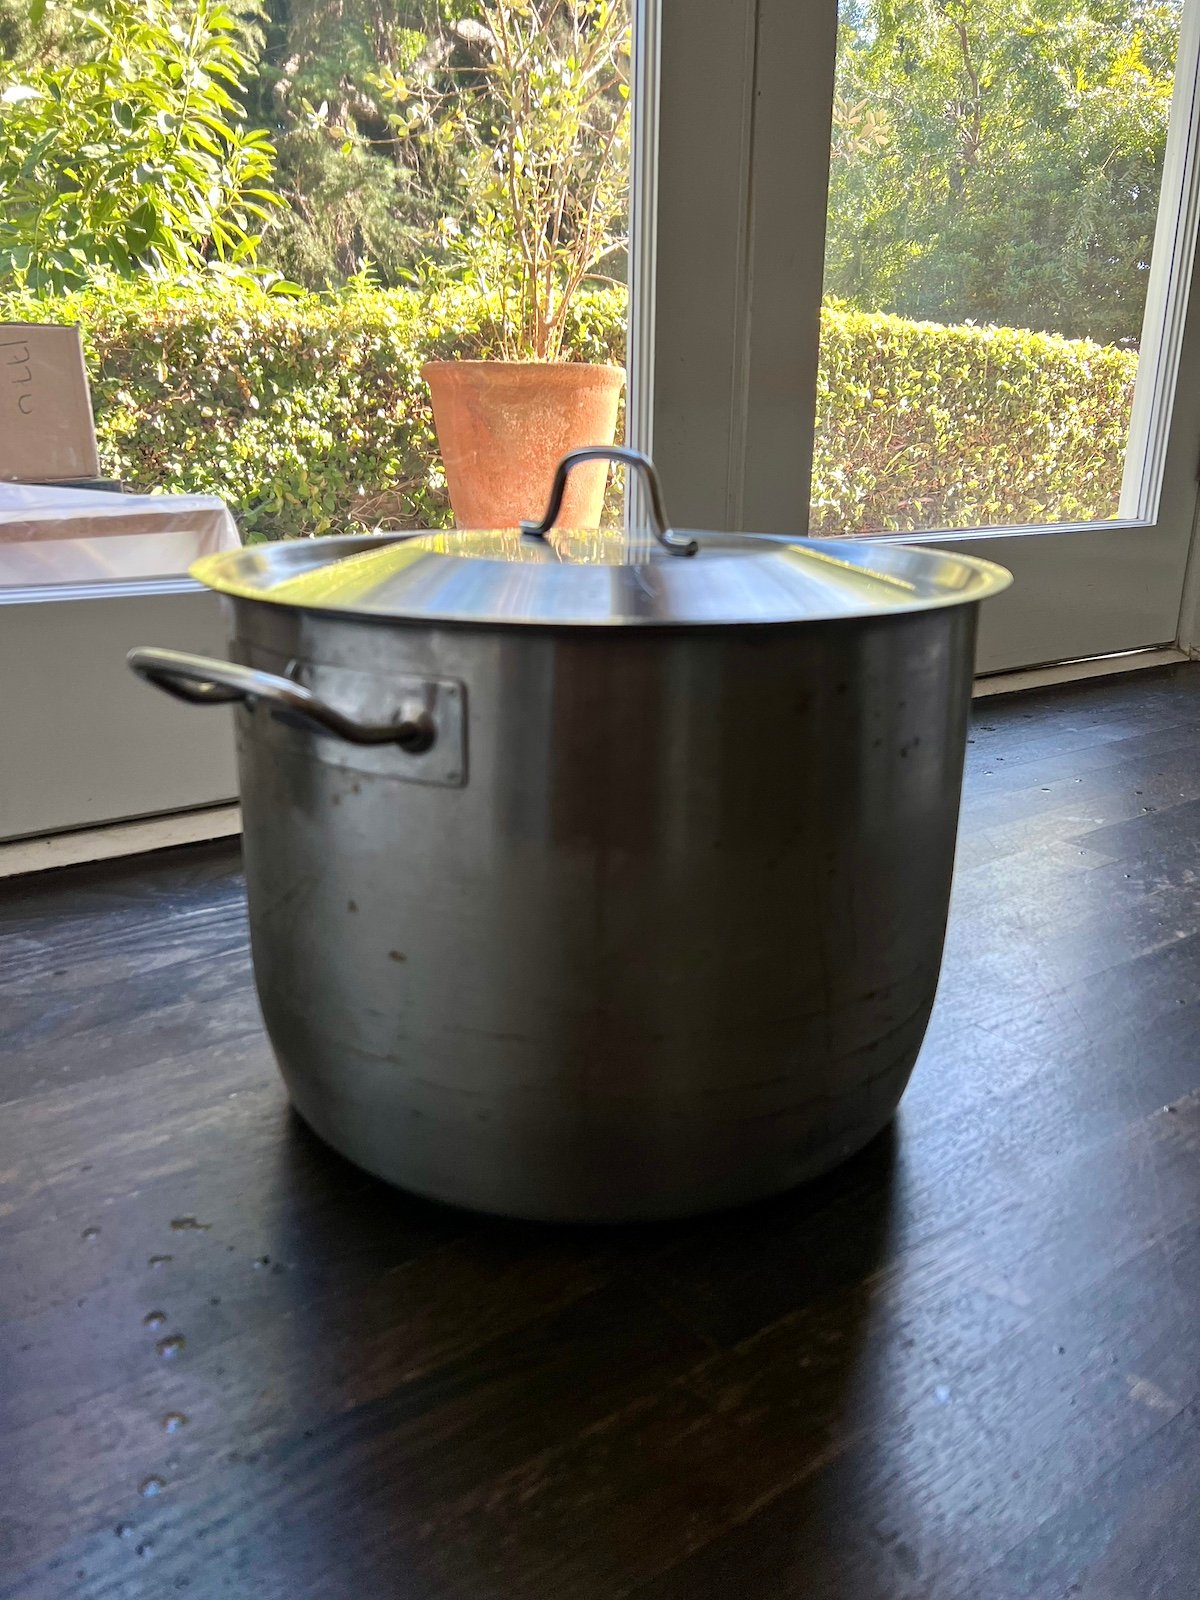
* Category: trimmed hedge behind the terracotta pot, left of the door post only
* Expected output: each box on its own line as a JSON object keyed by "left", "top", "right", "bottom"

{"left": 0, "top": 285, "right": 624, "bottom": 542}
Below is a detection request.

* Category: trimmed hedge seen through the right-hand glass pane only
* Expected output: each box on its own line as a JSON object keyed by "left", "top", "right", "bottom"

{"left": 811, "top": 306, "right": 1138, "bottom": 533}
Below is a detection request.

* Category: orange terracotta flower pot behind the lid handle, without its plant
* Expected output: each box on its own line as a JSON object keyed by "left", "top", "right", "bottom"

{"left": 421, "top": 362, "right": 626, "bottom": 528}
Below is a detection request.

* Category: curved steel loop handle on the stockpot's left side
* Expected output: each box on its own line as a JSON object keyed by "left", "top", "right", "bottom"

{"left": 126, "top": 646, "right": 437, "bottom": 755}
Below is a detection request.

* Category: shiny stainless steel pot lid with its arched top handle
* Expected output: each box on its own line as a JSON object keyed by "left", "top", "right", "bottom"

{"left": 190, "top": 448, "right": 1011, "bottom": 627}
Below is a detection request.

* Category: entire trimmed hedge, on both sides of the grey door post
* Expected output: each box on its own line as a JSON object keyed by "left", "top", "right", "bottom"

{"left": 0, "top": 285, "right": 1138, "bottom": 539}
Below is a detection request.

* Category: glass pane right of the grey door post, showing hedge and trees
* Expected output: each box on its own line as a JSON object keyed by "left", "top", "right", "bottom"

{"left": 811, "top": 0, "right": 1181, "bottom": 534}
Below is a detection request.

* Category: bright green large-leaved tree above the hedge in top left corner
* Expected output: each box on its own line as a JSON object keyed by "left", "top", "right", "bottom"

{"left": 0, "top": 0, "right": 278, "bottom": 291}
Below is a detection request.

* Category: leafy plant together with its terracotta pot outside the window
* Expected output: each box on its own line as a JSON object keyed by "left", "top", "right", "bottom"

{"left": 422, "top": 0, "right": 629, "bottom": 528}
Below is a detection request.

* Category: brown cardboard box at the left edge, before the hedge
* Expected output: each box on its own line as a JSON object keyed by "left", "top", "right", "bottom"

{"left": 0, "top": 322, "right": 99, "bottom": 483}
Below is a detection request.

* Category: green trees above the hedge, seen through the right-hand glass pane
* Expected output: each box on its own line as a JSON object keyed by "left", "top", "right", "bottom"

{"left": 826, "top": 0, "right": 1179, "bottom": 344}
